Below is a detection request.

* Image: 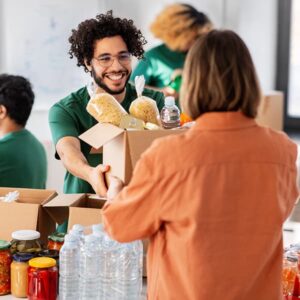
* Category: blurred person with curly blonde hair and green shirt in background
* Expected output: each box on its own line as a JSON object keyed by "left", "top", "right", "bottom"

{"left": 131, "top": 3, "right": 213, "bottom": 98}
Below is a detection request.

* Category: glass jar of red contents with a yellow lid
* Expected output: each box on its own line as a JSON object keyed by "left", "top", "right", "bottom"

{"left": 27, "top": 257, "right": 58, "bottom": 300}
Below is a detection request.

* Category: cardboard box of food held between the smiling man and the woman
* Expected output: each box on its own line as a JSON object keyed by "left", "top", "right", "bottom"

{"left": 79, "top": 123, "right": 184, "bottom": 184}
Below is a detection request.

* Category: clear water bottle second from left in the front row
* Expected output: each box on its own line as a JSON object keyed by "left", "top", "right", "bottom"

{"left": 76, "top": 234, "right": 101, "bottom": 300}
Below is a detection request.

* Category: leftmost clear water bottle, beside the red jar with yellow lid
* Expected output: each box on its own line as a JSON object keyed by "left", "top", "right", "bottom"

{"left": 59, "top": 234, "right": 79, "bottom": 300}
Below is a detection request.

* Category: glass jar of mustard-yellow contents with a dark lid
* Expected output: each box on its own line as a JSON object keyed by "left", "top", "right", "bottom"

{"left": 10, "top": 253, "right": 34, "bottom": 298}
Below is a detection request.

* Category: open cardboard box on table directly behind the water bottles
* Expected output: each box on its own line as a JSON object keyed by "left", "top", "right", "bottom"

{"left": 44, "top": 194, "right": 106, "bottom": 231}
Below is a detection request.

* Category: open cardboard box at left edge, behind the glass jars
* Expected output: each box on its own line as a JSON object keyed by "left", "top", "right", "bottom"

{"left": 0, "top": 188, "right": 56, "bottom": 242}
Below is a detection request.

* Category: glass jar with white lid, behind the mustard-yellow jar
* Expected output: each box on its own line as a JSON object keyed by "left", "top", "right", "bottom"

{"left": 10, "top": 230, "right": 42, "bottom": 254}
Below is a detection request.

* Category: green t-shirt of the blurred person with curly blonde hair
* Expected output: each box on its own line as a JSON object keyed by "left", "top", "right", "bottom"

{"left": 131, "top": 44, "right": 186, "bottom": 88}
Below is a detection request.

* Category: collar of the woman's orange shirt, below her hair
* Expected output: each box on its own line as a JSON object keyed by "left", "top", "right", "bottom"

{"left": 194, "top": 112, "right": 257, "bottom": 131}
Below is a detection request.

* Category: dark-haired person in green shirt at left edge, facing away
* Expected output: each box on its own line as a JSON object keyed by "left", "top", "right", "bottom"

{"left": 0, "top": 74, "right": 47, "bottom": 189}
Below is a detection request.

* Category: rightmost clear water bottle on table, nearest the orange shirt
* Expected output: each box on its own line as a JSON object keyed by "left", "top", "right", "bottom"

{"left": 117, "top": 241, "right": 143, "bottom": 300}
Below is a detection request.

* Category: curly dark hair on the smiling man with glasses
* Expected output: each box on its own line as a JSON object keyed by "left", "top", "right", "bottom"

{"left": 68, "top": 10, "right": 147, "bottom": 72}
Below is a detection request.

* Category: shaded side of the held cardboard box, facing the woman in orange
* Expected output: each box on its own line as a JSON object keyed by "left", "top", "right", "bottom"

{"left": 127, "top": 129, "right": 185, "bottom": 168}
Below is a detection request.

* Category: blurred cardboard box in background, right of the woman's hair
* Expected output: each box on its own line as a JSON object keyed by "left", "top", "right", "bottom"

{"left": 256, "top": 91, "right": 284, "bottom": 130}
